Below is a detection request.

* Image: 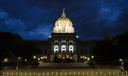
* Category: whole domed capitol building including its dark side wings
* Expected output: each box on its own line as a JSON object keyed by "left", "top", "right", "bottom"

{"left": 30, "top": 10, "right": 95, "bottom": 63}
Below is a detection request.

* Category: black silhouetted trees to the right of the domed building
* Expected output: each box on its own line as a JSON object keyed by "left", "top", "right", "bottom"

{"left": 93, "top": 33, "right": 128, "bottom": 65}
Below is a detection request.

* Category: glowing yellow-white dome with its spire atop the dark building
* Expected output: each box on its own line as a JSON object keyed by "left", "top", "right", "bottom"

{"left": 53, "top": 10, "right": 75, "bottom": 33}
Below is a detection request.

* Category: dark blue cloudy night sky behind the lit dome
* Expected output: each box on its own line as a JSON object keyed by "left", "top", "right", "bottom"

{"left": 0, "top": 0, "right": 128, "bottom": 40}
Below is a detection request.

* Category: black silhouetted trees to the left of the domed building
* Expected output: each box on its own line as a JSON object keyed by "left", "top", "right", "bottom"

{"left": 0, "top": 32, "right": 41, "bottom": 64}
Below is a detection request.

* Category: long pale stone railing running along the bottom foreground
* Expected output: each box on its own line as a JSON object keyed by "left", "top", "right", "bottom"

{"left": 2, "top": 71, "right": 128, "bottom": 76}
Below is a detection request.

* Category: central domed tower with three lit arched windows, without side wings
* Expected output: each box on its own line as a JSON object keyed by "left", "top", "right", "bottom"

{"left": 49, "top": 10, "right": 79, "bottom": 62}
